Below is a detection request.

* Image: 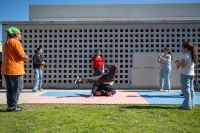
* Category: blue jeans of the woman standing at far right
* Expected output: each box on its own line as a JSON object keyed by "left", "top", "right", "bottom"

{"left": 180, "top": 74, "right": 194, "bottom": 109}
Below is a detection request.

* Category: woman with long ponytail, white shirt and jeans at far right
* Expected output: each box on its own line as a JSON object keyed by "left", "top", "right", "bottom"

{"left": 176, "top": 41, "right": 198, "bottom": 110}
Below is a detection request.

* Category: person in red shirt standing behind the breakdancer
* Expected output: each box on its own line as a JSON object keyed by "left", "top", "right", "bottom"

{"left": 92, "top": 50, "right": 104, "bottom": 87}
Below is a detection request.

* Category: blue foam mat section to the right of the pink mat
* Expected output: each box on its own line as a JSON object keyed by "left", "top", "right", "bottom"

{"left": 137, "top": 92, "right": 200, "bottom": 104}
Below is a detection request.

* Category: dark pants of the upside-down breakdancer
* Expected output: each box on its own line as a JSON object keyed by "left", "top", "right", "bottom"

{"left": 81, "top": 65, "right": 117, "bottom": 84}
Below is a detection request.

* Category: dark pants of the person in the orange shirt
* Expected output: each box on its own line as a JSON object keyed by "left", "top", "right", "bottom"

{"left": 4, "top": 75, "right": 24, "bottom": 107}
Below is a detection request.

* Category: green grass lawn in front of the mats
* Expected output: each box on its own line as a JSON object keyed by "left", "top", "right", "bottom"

{"left": 0, "top": 104, "right": 200, "bottom": 133}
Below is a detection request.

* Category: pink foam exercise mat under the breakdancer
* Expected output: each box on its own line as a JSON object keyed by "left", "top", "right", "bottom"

{"left": 24, "top": 92, "right": 149, "bottom": 104}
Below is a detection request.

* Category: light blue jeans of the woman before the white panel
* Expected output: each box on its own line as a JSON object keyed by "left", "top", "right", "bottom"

{"left": 159, "top": 69, "right": 171, "bottom": 90}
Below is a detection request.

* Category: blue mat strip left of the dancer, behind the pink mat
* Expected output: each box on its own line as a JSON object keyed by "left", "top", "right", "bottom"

{"left": 40, "top": 91, "right": 91, "bottom": 97}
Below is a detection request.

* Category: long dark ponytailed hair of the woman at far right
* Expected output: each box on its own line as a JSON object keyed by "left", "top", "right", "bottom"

{"left": 182, "top": 41, "right": 198, "bottom": 64}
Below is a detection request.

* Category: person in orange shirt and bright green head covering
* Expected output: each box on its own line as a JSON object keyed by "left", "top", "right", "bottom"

{"left": 1, "top": 27, "right": 29, "bottom": 112}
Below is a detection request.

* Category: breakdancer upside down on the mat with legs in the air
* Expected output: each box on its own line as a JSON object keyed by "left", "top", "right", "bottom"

{"left": 74, "top": 65, "right": 117, "bottom": 98}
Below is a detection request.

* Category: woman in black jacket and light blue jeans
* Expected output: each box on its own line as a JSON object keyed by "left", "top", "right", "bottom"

{"left": 33, "top": 48, "right": 45, "bottom": 92}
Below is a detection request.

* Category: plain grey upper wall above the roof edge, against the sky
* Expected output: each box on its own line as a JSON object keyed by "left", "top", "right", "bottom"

{"left": 29, "top": 3, "right": 200, "bottom": 21}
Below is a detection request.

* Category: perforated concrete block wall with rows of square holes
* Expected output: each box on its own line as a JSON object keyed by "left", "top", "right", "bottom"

{"left": 2, "top": 23, "right": 200, "bottom": 89}
